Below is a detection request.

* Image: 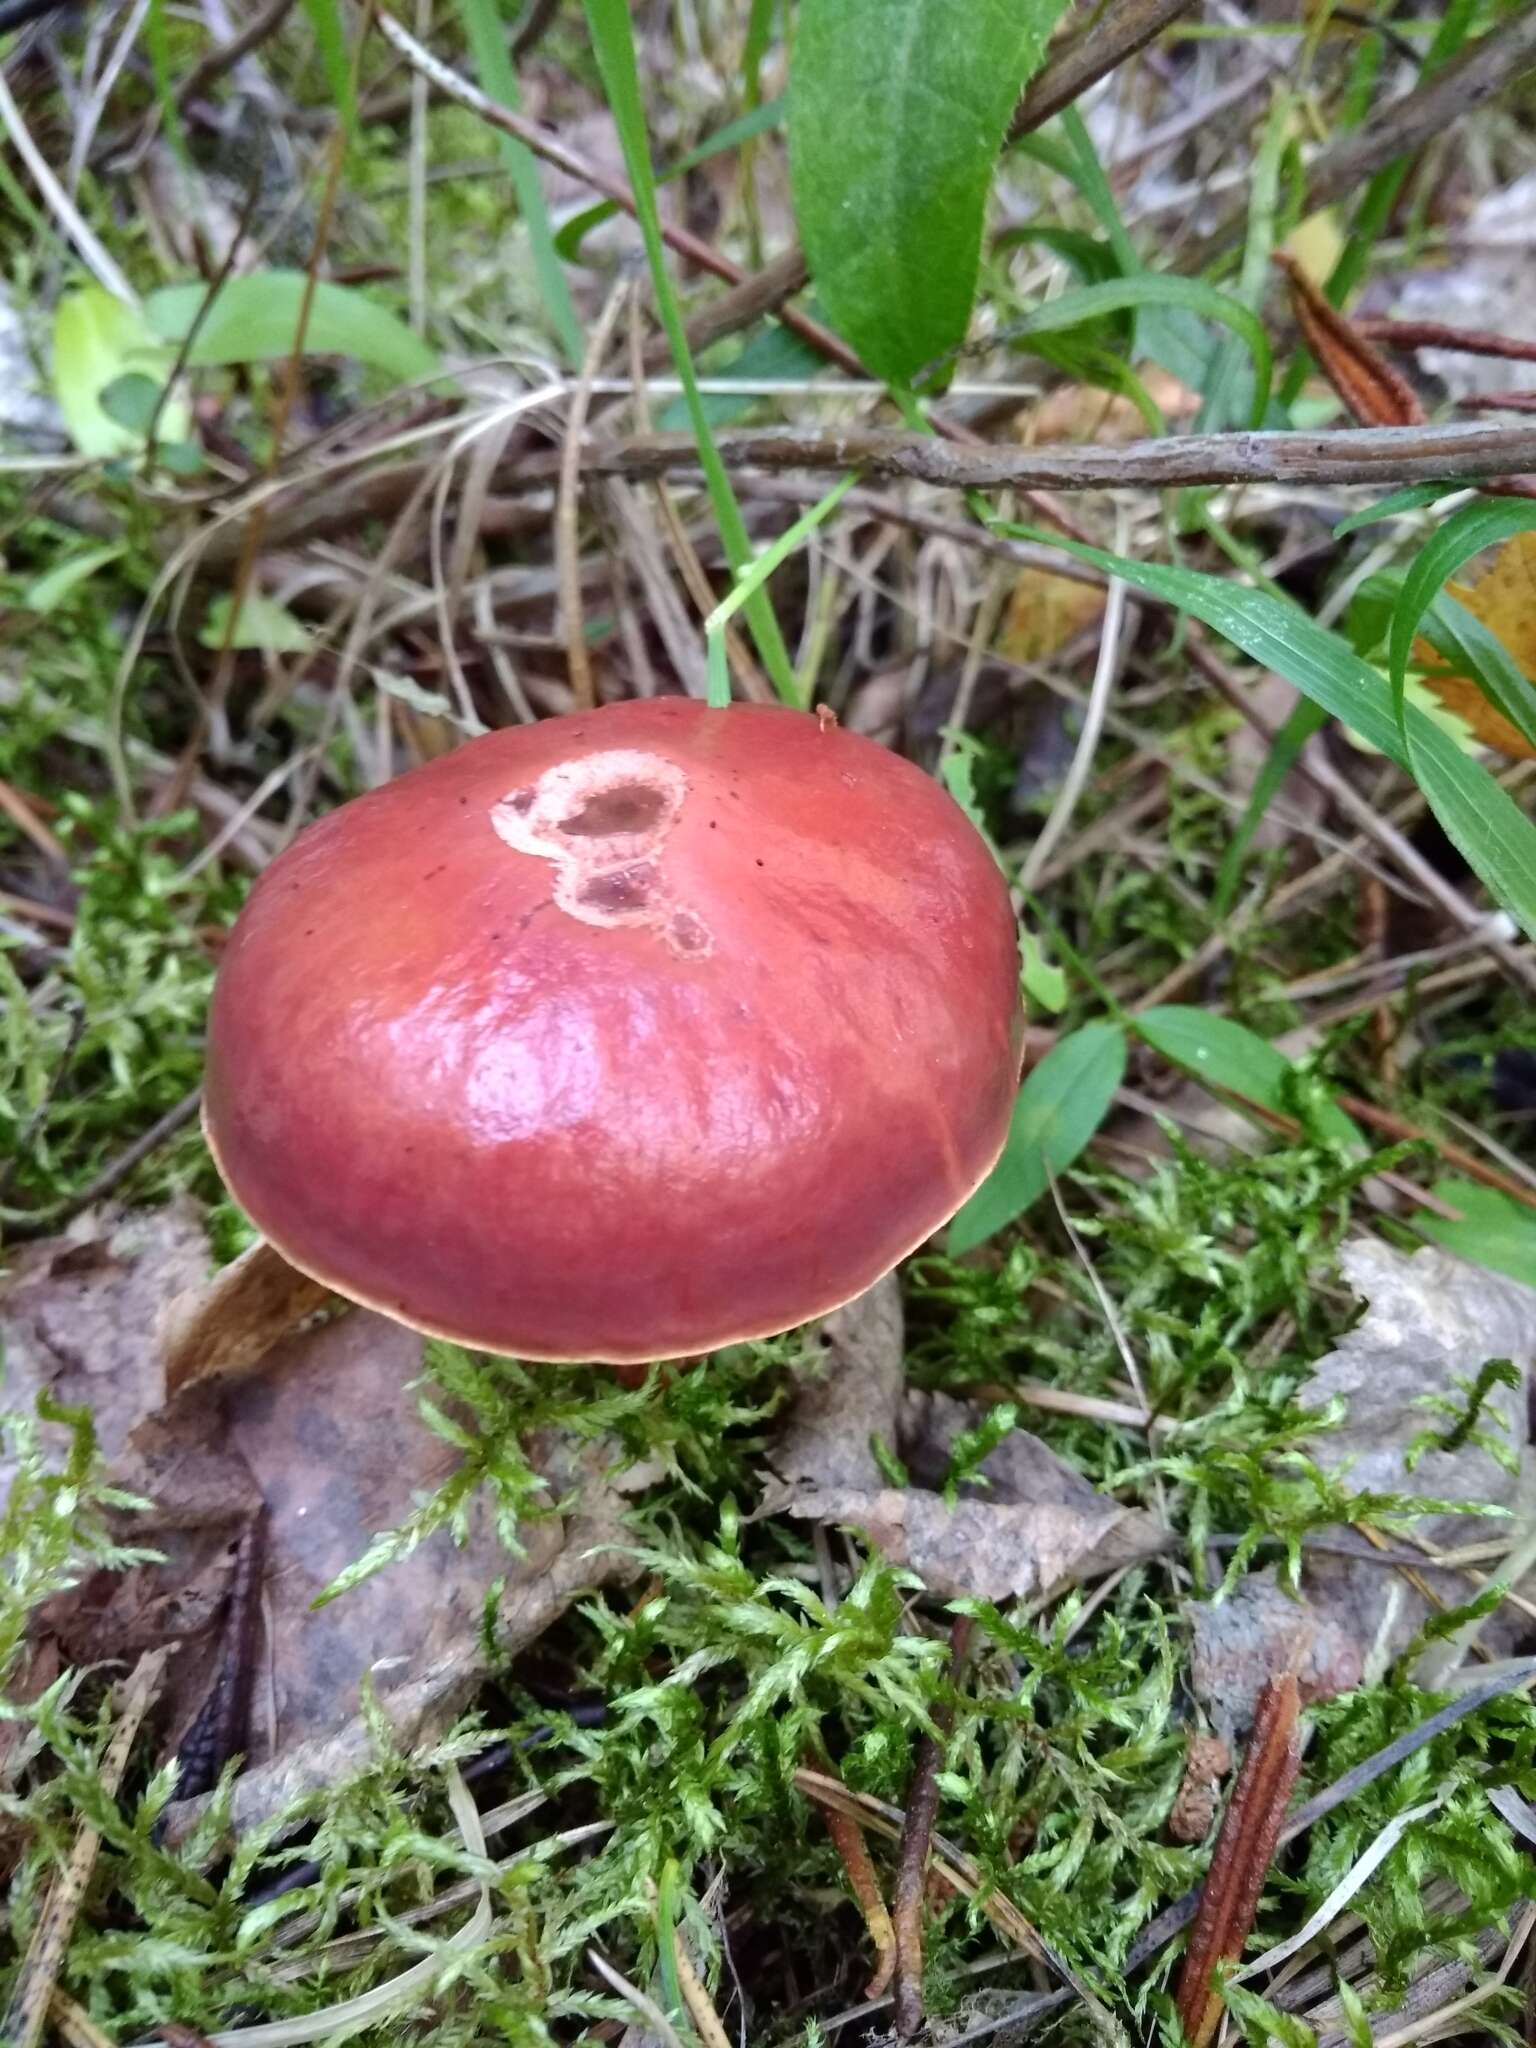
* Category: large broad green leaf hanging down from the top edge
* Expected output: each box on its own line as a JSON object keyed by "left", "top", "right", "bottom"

{"left": 788, "top": 0, "right": 1061, "bottom": 383}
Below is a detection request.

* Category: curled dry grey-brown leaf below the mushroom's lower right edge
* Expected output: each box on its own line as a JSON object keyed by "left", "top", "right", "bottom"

{"left": 758, "top": 1280, "right": 1171, "bottom": 1599}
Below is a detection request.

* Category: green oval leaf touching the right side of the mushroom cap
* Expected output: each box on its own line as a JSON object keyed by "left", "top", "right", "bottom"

{"left": 948, "top": 1024, "right": 1126, "bottom": 1255}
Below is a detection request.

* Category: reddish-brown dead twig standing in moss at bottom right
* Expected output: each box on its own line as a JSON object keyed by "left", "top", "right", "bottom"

{"left": 1178, "top": 1673, "right": 1300, "bottom": 2048}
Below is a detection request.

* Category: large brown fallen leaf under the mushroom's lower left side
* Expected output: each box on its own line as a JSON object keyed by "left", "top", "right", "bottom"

{"left": 0, "top": 1204, "right": 633, "bottom": 1835}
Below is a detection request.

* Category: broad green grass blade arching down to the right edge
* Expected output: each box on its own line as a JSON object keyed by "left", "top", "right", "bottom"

{"left": 995, "top": 522, "right": 1536, "bottom": 934}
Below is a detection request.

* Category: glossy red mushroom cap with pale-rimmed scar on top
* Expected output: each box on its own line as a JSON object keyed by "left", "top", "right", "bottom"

{"left": 205, "top": 698, "right": 1022, "bottom": 1362}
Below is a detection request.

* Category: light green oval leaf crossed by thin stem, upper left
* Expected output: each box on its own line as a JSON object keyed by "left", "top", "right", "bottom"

{"left": 143, "top": 270, "right": 442, "bottom": 385}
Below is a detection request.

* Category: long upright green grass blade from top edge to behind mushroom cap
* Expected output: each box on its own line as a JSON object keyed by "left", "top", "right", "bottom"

{"left": 586, "top": 0, "right": 799, "bottom": 705}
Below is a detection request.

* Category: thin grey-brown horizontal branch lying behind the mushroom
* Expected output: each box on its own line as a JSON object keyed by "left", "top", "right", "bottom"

{"left": 532, "top": 422, "right": 1536, "bottom": 492}
